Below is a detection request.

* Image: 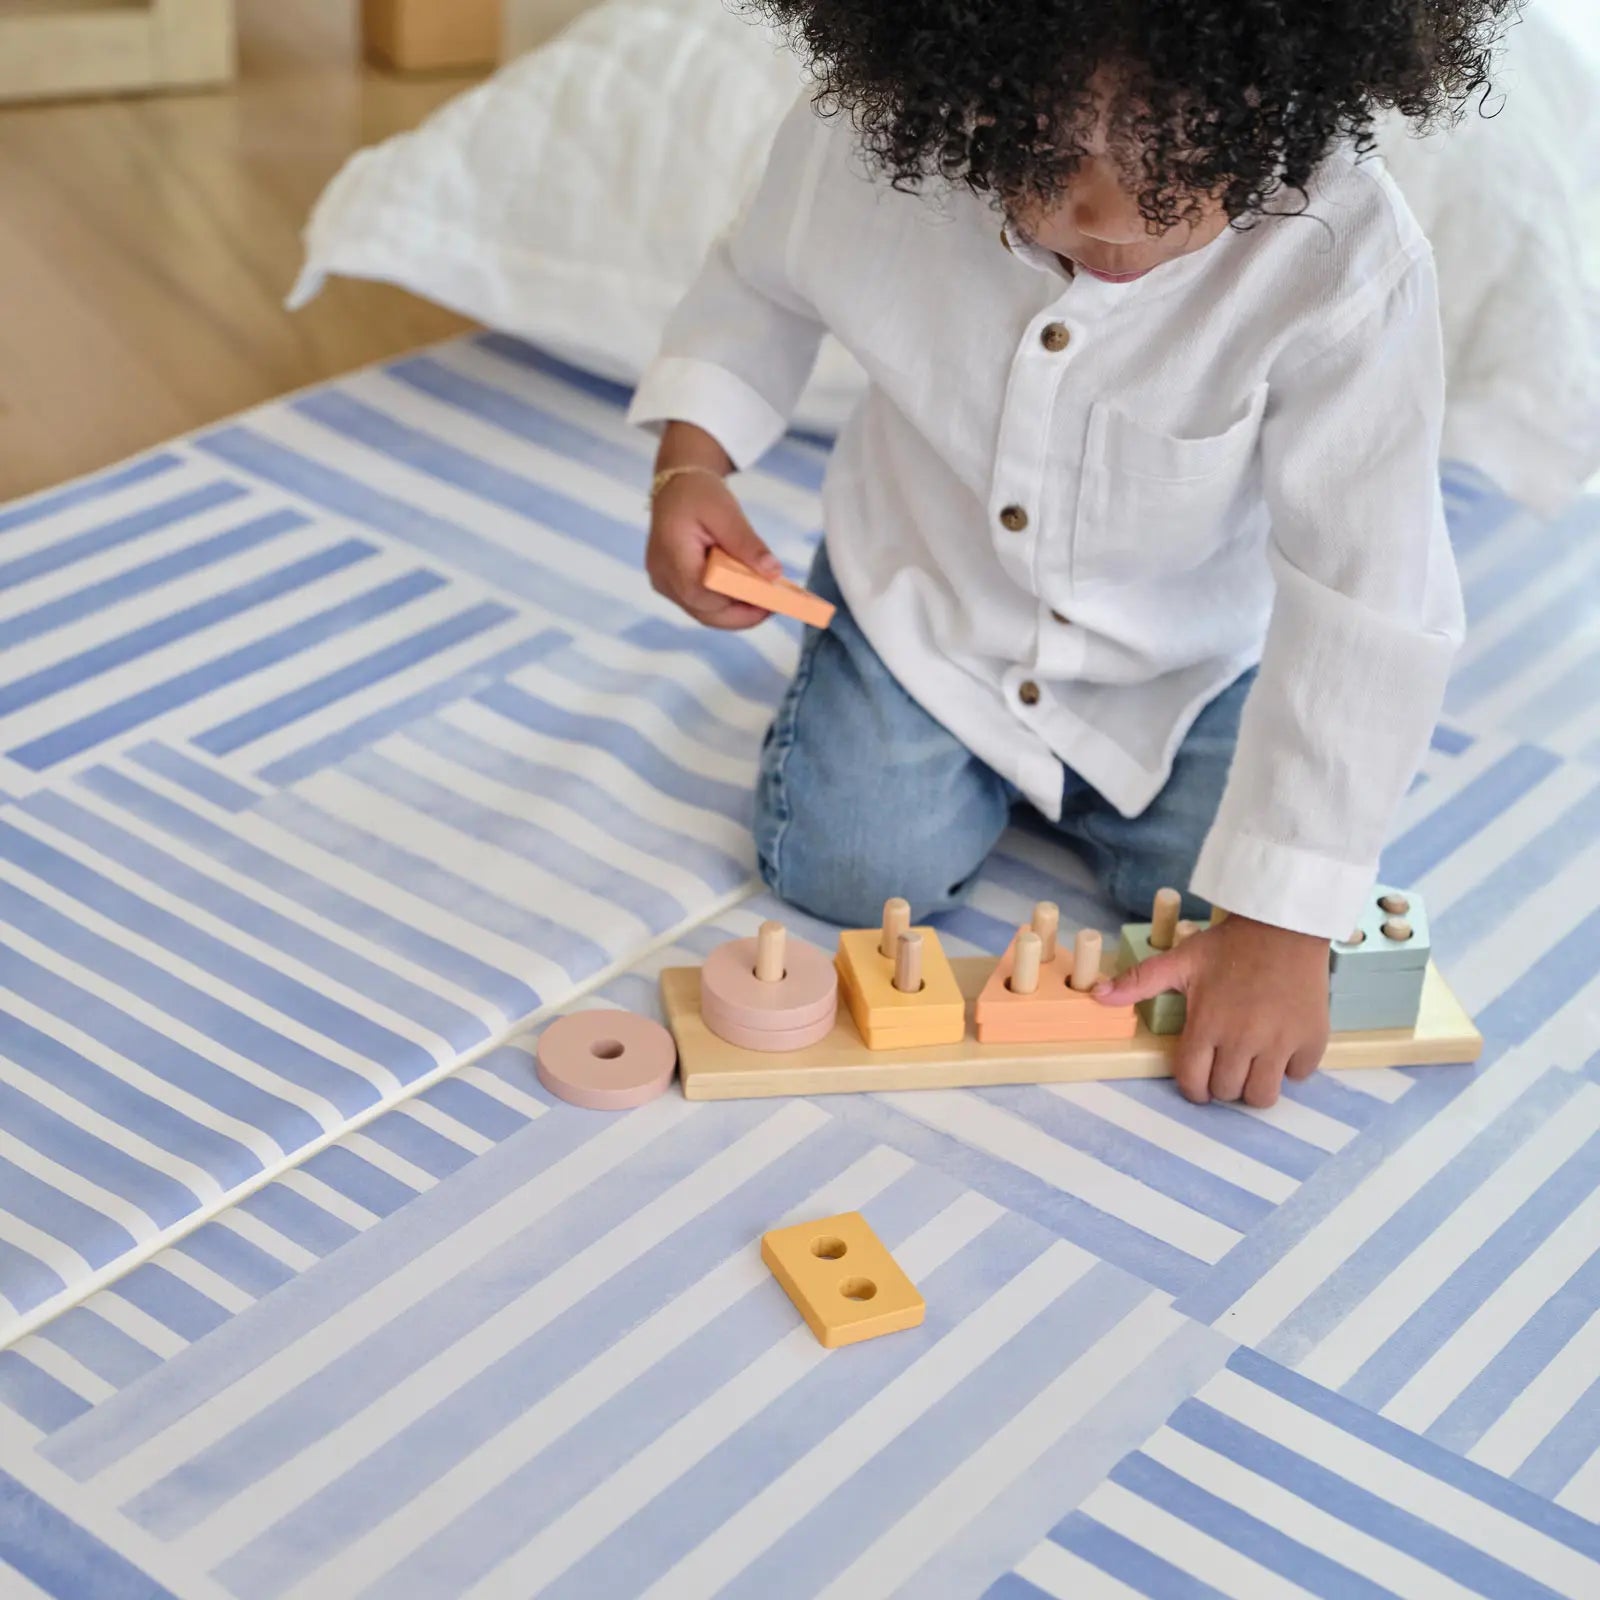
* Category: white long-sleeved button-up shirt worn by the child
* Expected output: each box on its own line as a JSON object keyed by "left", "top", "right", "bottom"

{"left": 630, "top": 101, "right": 1462, "bottom": 938}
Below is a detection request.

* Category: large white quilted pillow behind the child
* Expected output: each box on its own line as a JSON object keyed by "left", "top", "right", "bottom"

{"left": 291, "top": 0, "right": 1600, "bottom": 510}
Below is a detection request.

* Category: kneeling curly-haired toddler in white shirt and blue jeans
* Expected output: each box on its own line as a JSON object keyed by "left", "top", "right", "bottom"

{"left": 632, "top": 0, "right": 1514, "bottom": 1106}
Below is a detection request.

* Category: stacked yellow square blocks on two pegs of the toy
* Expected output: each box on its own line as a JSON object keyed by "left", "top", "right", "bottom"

{"left": 837, "top": 899, "right": 966, "bottom": 1050}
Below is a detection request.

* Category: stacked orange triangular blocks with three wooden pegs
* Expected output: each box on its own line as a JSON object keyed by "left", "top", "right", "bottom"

{"left": 973, "top": 902, "right": 1138, "bottom": 1045}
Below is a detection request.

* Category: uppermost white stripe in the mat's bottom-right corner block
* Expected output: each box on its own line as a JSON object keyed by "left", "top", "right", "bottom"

{"left": 1200, "top": 1371, "right": 1600, "bottom": 1600}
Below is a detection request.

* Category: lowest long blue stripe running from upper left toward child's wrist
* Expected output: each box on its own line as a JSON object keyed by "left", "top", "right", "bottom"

{"left": 195, "top": 427, "right": 645, "bottom": 630}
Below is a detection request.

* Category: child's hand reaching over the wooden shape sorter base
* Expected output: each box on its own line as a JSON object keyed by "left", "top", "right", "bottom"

{"left": 1094, "top": 917, "right": 1328, "bottom": 1106}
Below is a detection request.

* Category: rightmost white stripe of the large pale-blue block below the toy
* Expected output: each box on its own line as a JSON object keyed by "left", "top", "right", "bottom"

{"left": 818, "top": 1294, "right": 1184, "bottom": 1600}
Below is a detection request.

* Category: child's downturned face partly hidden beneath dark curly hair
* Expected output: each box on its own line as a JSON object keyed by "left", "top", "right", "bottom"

{"left": 1011, "top": 79, "right": 1227, "bottom": 283}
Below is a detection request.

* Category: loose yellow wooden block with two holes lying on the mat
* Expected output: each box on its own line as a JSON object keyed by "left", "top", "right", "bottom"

{"left": 762, "top": 1211, "right": 928, "bottom": 1350}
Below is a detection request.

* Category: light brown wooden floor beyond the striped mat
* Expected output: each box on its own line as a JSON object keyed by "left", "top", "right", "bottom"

{"left": 0, "top": 0, "right": 469, "bottom": 499}
